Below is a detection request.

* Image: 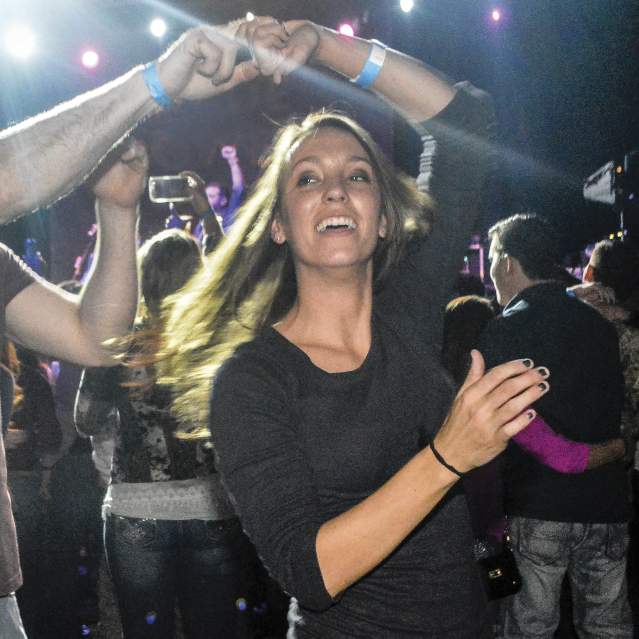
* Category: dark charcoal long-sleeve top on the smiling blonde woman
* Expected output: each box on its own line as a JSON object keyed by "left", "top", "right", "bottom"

{"left": 211, "top": 85, "right": 493, "bottom": 639}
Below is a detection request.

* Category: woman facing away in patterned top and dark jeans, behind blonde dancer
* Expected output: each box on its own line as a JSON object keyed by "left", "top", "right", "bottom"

{"left": 76, "top": 229, "right": 251, "bottom": 639}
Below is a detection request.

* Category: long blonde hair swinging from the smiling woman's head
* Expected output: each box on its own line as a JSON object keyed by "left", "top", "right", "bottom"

{"left": 158, "top": 111, "right": 432, "bottom": 436}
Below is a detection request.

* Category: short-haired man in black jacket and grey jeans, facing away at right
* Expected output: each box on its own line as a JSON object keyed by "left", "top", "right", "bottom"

{"left": 480, "top": 215, "right": 632, "bottom": 639}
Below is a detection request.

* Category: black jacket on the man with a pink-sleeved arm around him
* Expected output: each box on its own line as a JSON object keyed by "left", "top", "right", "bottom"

{"left": 480, "top": 282, "right": 629, "bottom": 523}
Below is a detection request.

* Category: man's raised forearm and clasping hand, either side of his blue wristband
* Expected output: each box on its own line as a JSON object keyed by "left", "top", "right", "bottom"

{"left": 0, "top": 23, "right": 257, "bottom": 224}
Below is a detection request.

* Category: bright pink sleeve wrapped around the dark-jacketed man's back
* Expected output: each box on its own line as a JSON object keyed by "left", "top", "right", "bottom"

{"left": 513, "top": 416, "right": 590, "bottom": 473}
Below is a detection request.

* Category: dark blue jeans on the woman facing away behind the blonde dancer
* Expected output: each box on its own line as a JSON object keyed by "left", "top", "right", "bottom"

{"left": 104, "top": 515, "right": 253, "bottom": 639}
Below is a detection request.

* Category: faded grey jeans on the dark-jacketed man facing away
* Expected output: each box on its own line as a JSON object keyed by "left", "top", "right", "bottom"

{"left": 503, "top": 517, "right": 633, "bottom": 639}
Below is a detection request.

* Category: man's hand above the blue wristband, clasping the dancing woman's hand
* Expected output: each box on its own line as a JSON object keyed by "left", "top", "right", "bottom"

{"left": 158, "top": 20, "right": 259, "bottom": 100}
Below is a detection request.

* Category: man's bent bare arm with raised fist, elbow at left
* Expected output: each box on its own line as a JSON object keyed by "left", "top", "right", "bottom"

{"left": 6, "top": 143, "right": 148, "bottom": 366}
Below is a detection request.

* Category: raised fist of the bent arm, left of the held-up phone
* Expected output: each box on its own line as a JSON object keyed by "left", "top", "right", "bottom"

{"left": 93, "top": 140, "right": 149, "bottom": 210}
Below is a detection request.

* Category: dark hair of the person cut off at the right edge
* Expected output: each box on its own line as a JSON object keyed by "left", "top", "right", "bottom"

{"left": 590, "top": 240, "right": 639, "bottom": 302}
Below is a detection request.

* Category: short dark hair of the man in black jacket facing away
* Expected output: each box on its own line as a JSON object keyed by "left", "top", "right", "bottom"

{"left": 488, "top": 213, "right": 560, "bottom": 279}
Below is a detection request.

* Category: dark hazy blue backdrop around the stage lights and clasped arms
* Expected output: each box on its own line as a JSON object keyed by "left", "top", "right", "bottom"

{"left": 0, "top": 0, "right": 639, "bottom": 281}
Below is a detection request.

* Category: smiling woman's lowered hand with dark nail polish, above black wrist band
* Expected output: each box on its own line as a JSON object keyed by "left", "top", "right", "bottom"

{"left": 434, "top": 350, "right": 550, "bottom": 472}
